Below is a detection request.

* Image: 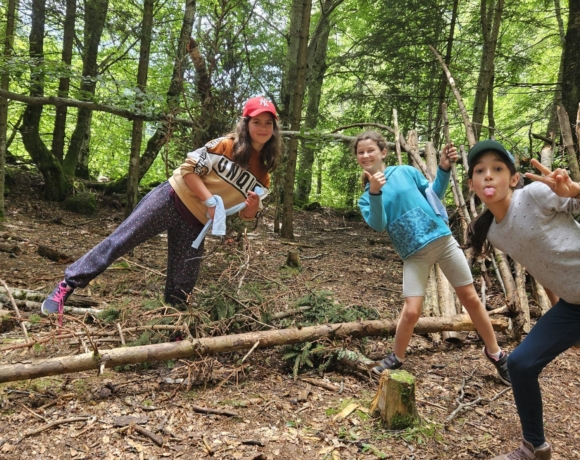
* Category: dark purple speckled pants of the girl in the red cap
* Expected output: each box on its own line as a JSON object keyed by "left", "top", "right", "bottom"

{"left": 65, "top": 182, "right": 203, "bottom": 304}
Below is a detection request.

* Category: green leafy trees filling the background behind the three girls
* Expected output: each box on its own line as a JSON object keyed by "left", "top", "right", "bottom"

{"left": 0, "top": 0, "right": 580, "bottom": 216}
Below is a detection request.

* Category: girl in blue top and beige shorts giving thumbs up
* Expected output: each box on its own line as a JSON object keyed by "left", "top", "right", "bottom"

{"left": 354, "top": 131, "right": 510, "bottom": 385}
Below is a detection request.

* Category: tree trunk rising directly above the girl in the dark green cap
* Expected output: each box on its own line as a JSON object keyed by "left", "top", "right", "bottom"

{"left": 471, "top": 0, "right": 504, "bottom": 140}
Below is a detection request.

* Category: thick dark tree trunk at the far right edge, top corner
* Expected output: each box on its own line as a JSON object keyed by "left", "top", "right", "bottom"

{"left": 560, "top": 0, "right": 580, "bottom": 128}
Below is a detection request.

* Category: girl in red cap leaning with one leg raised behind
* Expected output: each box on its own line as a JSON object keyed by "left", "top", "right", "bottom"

{"left": 41, "top": 97, "right": 281, "bottom": 314}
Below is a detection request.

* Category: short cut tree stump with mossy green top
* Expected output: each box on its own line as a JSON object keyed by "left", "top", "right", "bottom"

{"left": 371, "top": 369, "right": 419, "bottom": 430}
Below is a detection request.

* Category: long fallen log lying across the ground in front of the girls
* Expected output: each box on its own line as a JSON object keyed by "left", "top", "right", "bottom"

{"left": 0, "top": 315, "right": 509, "bottom": 383}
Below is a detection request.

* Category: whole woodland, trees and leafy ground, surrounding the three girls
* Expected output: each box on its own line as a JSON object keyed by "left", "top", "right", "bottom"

{"left": 0, "top": 0, "right": 580, "bottom": 460}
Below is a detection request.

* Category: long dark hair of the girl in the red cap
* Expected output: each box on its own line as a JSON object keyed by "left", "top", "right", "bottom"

{"left": 227, "top": 117, "right": 282, "bottom": 172}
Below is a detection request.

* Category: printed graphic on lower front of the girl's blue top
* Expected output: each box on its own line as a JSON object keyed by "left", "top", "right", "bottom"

{"left": 387, "top": 207, "right": 437, "bottom": 259}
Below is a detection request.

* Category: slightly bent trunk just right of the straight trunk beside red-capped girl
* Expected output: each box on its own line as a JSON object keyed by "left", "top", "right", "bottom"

{"left": 296, "top": 0, "right": 343, "bottom": 205}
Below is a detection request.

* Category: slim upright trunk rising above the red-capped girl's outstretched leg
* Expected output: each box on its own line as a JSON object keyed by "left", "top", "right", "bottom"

{"left": 125, "top": 0, "right": 153, "bottom": 217}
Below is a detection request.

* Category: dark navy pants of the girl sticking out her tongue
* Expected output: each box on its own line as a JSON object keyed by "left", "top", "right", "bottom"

{"left": 508, "top": 300, "right": 580, "bottom": 447}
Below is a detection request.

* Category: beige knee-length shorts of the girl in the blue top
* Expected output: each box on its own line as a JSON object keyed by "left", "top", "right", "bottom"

{"left": 403, "top": 236, "right": 473, "bottom": 297}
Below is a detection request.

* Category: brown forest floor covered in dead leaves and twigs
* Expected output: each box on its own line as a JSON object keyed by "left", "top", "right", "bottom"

{"left": 0, "top": 166, "right": 580, "bottom": 460}
